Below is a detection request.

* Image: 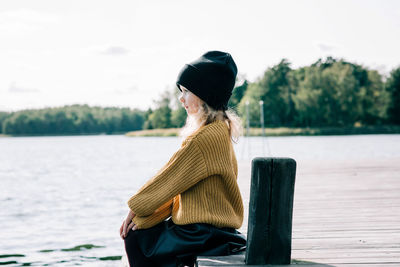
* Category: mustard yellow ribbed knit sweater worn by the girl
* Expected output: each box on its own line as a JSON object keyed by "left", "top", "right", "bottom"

{"left": 128, "top": 121, "right": 243, "bottom": 229}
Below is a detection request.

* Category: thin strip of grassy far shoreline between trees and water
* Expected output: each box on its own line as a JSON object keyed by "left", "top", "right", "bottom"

{"left": 0, "top": 125, "right": 400, "bottom": 138}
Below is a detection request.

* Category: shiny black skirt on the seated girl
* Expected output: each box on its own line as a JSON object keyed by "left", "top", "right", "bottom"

{"left": 125, "top": 219, "right": 246, "bottom": 267}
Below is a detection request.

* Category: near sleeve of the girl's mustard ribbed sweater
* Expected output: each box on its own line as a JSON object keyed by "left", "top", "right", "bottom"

{"left": 128, "top": 139, "right": 208, "bottom": 219}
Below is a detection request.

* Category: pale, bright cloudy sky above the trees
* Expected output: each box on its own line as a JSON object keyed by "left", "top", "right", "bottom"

{"left": 0, "top": 0, "right": 400, "bottom": 111}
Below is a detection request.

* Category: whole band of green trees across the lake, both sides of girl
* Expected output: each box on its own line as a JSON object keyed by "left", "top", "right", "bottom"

{"left": 0, "top": 57, "right": 400, "bottom": 135}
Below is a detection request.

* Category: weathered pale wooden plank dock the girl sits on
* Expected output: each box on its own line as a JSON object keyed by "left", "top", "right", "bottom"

{"left": 199, "top": 159, "right": 400, "bottom": 267}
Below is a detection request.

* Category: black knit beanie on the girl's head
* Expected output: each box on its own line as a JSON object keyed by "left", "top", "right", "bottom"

{"left": 176, "top": 51, "right": 237, "bottom": 110}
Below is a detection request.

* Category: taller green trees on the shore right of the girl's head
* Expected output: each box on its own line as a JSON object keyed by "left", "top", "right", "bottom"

{"left": 237, "top": 57, "right": 400, "bottom": 127}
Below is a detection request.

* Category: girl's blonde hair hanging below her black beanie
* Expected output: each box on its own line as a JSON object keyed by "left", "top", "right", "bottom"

{"left": 180, "top": 101, "right": 243, "bottom": 143}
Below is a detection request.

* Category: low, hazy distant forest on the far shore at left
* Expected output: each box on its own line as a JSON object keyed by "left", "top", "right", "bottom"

{"left": 0, "top": 105, "right": 144, "bottom": 135}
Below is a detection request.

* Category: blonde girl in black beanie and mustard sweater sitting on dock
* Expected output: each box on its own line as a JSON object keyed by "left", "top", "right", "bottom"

{"left": 120, "top": 51, "right": 246, "bottom": 267}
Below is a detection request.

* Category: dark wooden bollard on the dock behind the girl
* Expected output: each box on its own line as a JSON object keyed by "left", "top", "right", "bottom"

{"left": 246, "top": 158, "right": 296, "bottom": 265}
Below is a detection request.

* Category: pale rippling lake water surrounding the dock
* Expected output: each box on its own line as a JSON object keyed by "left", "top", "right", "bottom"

{"left": 0, "top": 135, "right": 400, "bottom": 266}
